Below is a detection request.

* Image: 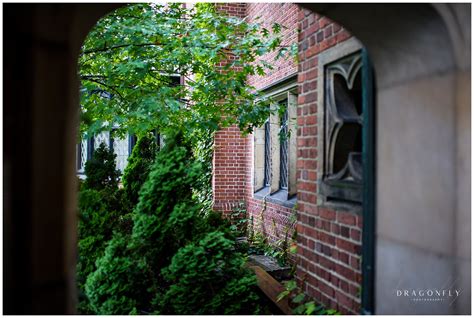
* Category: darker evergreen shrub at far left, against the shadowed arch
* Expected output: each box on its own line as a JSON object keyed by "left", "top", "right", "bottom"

{"left": 77, "top": 148, "right": 130, "bottom": 314}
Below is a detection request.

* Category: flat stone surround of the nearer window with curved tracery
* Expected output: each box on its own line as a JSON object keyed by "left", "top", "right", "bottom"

{"left": 316, "top": 38, "right": 363, "bottom": 213}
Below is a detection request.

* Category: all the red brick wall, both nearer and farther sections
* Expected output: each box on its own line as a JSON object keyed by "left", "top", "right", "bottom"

{"left": 213, "top": 3, "right": 362, "bottom": 314}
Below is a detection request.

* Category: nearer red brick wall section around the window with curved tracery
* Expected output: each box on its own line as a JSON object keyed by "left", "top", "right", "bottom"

{"left": 297, "top": 10, "right": 362, "bottom": 314}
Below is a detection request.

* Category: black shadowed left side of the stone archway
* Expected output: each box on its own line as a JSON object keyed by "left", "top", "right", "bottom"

{"left": 3, "top": 4, "right": 118, "bottom": 314}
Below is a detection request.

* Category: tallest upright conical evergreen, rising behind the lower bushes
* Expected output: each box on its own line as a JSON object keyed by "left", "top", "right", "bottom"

{"left": 132, "top": 137, "right": 204, "bottom": 271}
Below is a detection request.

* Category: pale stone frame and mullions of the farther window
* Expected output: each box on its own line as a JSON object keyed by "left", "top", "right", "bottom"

{"left": 252, "top": 76, "right": 298, "bottom": 207}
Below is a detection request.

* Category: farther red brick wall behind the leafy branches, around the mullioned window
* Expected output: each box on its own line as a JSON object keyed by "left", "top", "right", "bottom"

{"left": 213, "top": 3, "right": 299, "bottom": 221}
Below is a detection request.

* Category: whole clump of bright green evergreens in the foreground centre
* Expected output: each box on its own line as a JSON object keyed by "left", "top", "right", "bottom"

{"left": 86, "top": 135, "right": 259, "bottom": 314}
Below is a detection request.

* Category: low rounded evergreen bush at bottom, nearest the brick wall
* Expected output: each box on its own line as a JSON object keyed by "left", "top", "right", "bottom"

{"left": 159, "top": 232, "right": 259, "bottom": 315}
